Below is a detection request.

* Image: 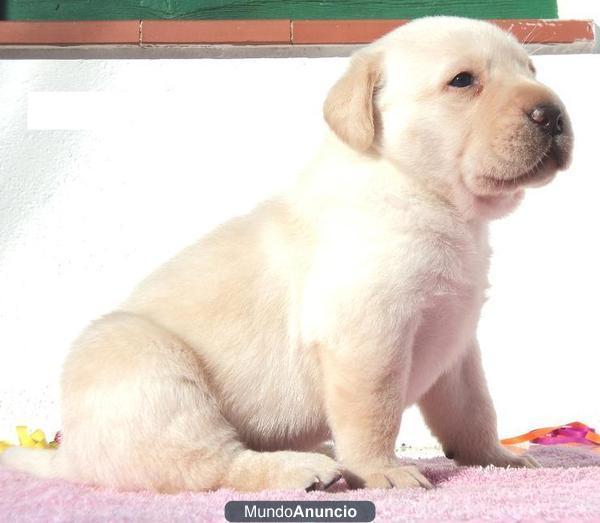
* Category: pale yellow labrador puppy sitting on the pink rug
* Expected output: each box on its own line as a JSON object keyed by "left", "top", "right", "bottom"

{"left": 2, "top": 17, "right": 572, "bottom": 492}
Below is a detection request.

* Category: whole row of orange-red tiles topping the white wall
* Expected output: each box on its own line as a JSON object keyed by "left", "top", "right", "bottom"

{"left": 0, "top": 20, "right": 594, "bottom": 45}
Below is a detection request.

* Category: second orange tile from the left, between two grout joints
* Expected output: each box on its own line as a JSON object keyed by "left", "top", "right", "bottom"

{"left": 142, "top": 20, "right": 291, "bottom": 44}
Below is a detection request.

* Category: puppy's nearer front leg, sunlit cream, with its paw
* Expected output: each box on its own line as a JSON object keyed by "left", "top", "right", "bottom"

{"left": 321, "top": 316, "right": 431, "bottom": 488}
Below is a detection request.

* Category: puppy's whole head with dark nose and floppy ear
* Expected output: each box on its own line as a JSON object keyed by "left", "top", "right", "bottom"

{"left": 324, "top": 17, "right": 573, "bottom": 217}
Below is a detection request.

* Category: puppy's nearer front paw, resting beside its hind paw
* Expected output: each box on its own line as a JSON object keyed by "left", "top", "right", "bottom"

{"left": 343, "top": 465, "right": 433, "bottom": 489}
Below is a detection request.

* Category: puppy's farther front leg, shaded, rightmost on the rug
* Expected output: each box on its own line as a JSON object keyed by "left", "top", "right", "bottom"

{"left": 419, "top": 342, "right": 539, "bottom": 467}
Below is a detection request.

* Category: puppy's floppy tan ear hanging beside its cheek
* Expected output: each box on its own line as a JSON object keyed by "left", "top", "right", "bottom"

{"left": 323, "top": 53, "right": 381, "bottom": 152}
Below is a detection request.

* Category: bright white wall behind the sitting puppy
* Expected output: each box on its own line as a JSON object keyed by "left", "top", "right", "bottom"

{"left": 0, "top": 55, "right": 600, "bottom": 443}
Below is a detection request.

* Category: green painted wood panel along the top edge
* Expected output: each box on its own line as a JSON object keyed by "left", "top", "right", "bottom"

{"left": 0, "top": 0, "right": 558, "bottom": 20}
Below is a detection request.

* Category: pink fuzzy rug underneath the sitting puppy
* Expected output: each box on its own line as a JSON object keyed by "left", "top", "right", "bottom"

{"left": 0, "top": 447, "right": 600, "bottom": 523}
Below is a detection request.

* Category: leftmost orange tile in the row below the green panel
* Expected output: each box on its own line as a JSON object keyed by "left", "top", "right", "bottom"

{"left": 0, "top": 20, "right": 140, "bottom": 45}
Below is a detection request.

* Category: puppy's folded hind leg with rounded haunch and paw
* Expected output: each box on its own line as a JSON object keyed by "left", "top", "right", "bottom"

{"left": 59, "top": 313, "right": 339, "bottom": 492}
